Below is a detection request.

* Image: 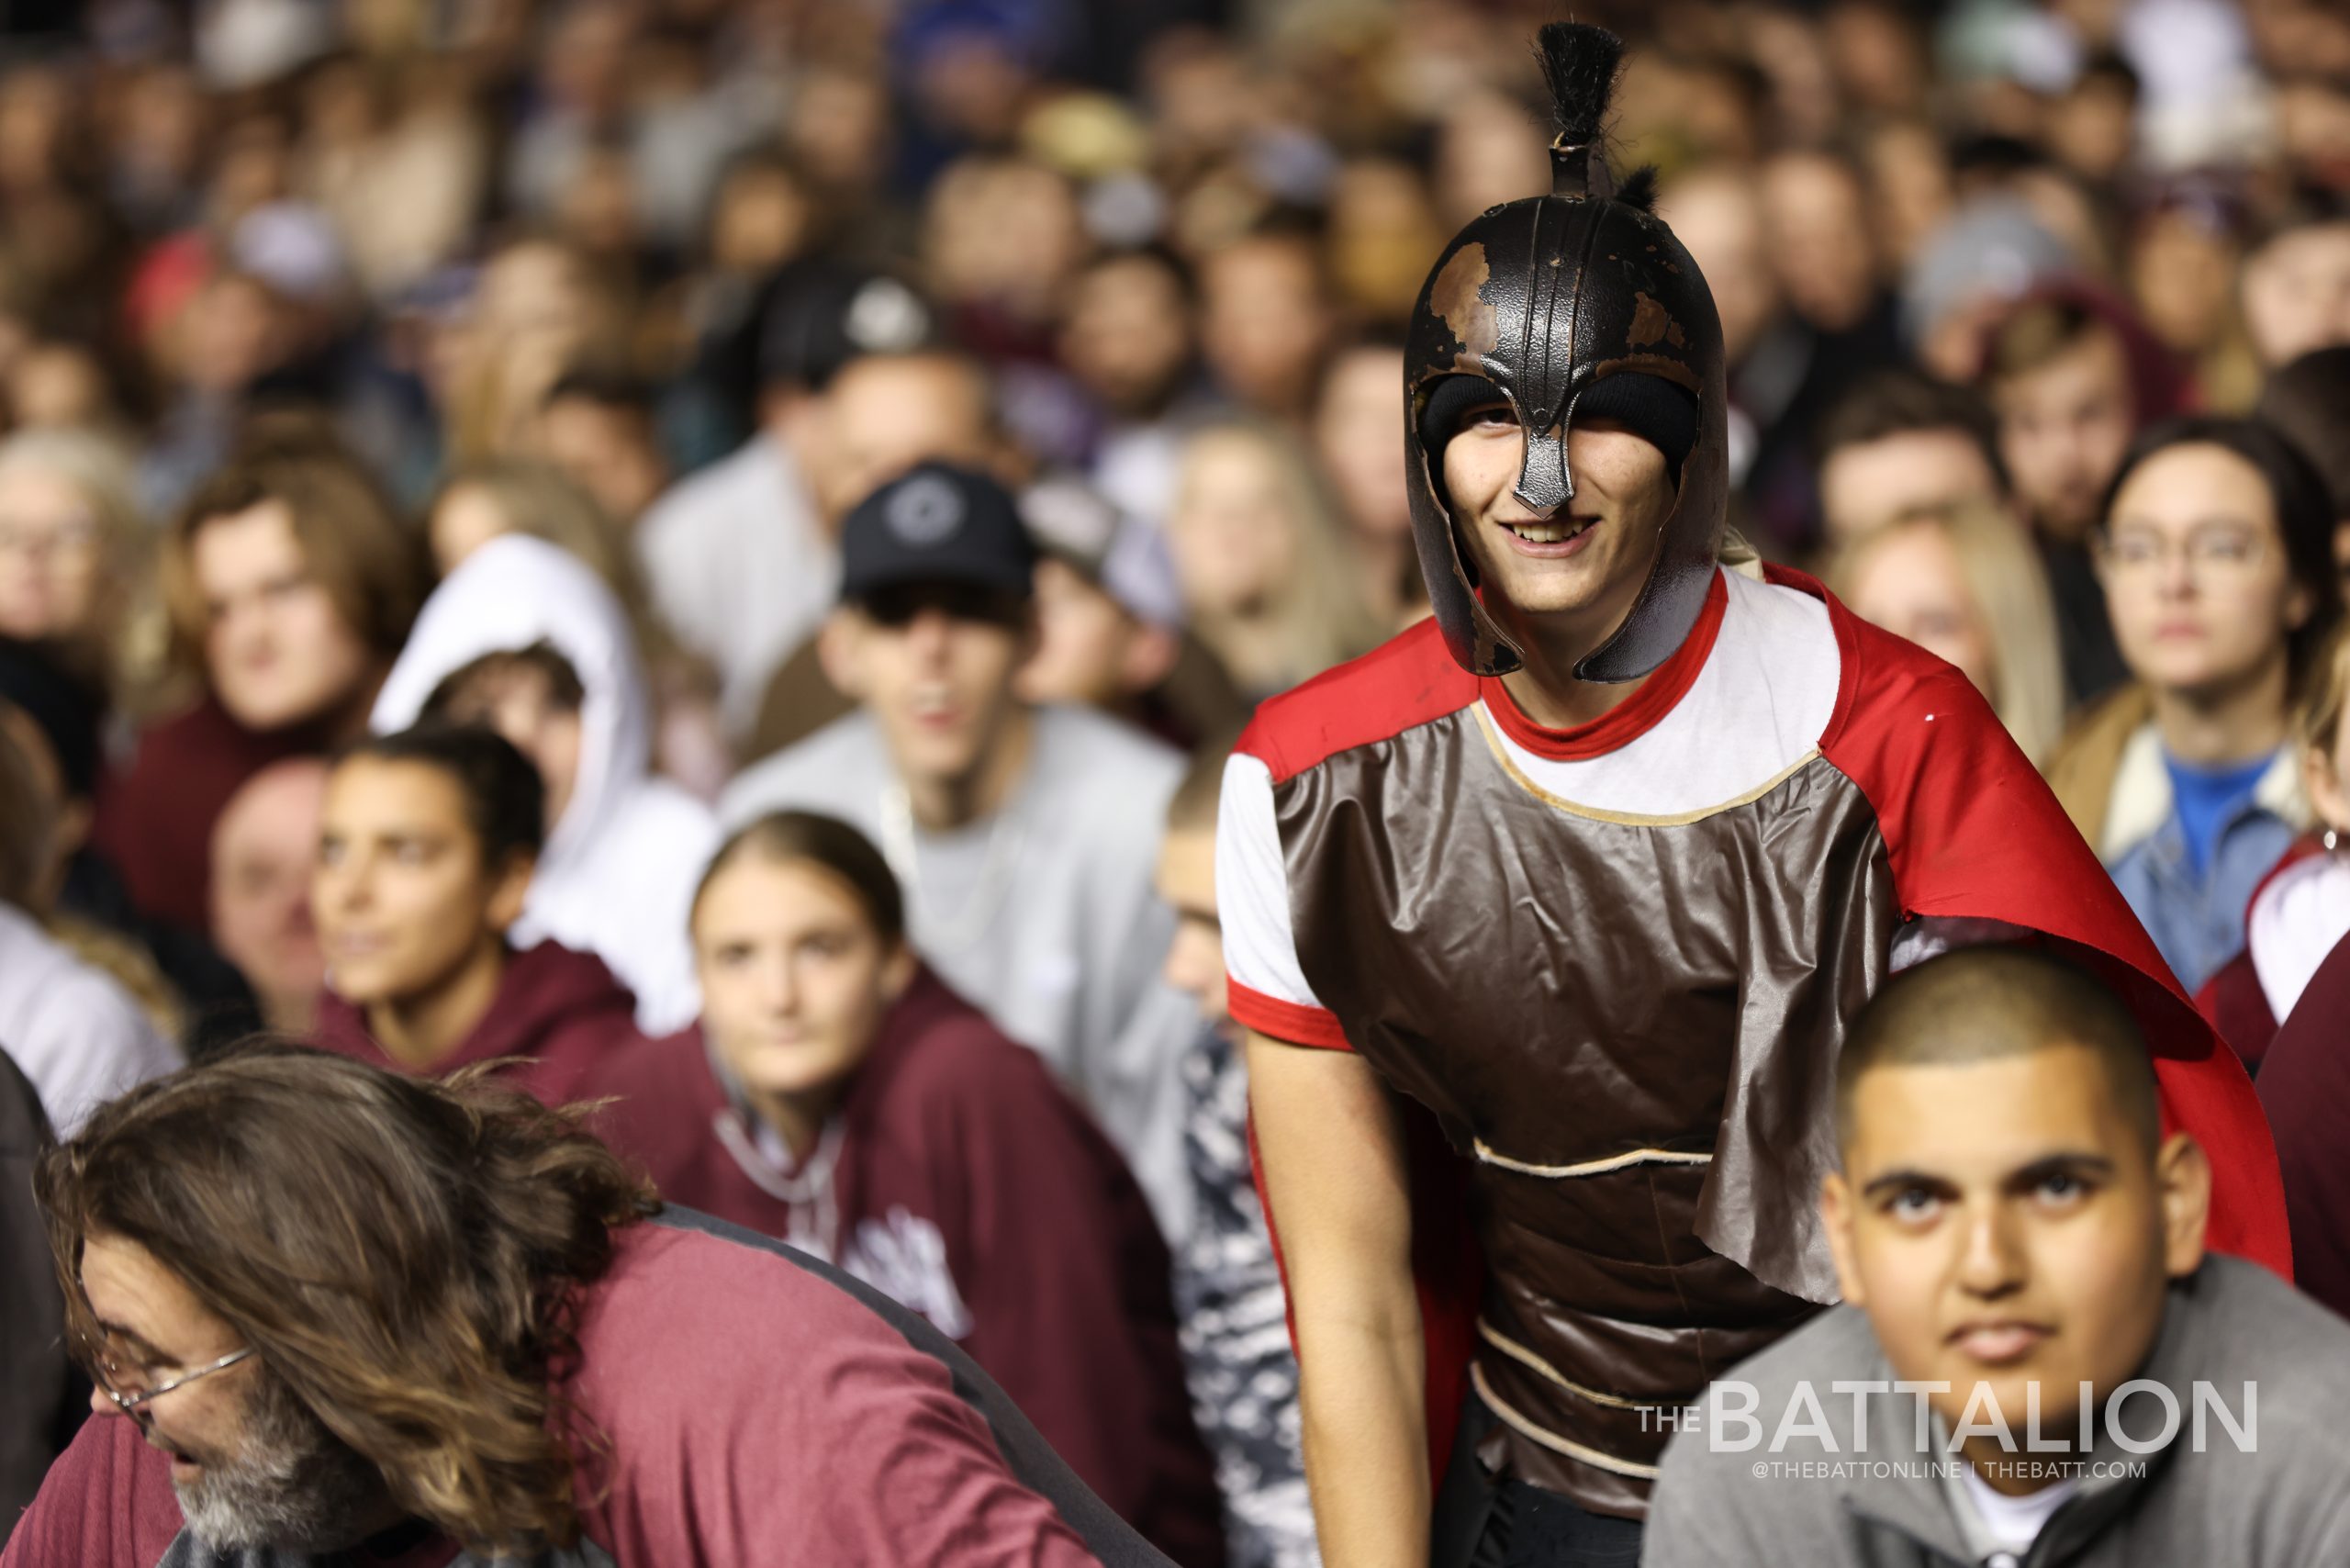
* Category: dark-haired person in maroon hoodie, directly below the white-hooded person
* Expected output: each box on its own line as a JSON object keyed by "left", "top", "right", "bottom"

{"left": 310, "top": 724, "right": 634, "bottom": 1105}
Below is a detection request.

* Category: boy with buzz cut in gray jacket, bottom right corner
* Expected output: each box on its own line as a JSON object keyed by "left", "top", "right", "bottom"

{"left": 1640, "top": 947, "right": 2350, "bottom": 1568}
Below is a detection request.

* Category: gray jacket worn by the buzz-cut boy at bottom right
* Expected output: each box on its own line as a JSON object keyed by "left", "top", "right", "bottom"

{"left": 1640, "top": 1255, "right": 2350, "bottom": 1568}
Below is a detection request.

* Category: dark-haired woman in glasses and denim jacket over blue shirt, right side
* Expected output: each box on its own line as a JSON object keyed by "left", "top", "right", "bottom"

{"left": 2049, "top": 419, "right": 2341, "bottom": 992}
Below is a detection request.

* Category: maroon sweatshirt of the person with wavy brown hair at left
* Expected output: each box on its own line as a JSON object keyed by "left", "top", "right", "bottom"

{"left": 92, "top": 696, "right": 308, "bottom": 931}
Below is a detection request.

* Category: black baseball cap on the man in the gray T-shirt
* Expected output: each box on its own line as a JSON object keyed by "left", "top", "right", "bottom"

{"left": 841, "top": 463, "right": 1036, "bottom": 604}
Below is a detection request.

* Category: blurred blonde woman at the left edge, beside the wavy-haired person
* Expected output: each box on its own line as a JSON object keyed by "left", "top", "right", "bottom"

{"left": 0, "top": 431, "right": 164, "bottom": 703}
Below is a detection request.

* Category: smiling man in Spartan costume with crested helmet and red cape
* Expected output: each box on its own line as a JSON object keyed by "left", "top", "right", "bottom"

{"left": 1217, "top": 24, "right": 2288, "bottom": 1568}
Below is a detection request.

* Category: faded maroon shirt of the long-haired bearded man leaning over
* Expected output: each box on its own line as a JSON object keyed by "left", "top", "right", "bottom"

{"left": 0, "top": 1215, "right": 1166, "bottom": 1568}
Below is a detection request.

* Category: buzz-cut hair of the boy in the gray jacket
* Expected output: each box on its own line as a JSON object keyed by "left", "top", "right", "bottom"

{"left": 1835, "top": 945, "right": 2162, "bottom": 1154}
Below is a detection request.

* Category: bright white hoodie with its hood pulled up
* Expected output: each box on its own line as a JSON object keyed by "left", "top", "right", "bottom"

{"left": 374, "top": 533, "right": 719, "bottom": 1035}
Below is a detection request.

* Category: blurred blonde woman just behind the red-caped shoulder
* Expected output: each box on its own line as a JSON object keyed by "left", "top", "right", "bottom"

{"left": 1829, "top": 500, "right": 2064, "bottom": 764}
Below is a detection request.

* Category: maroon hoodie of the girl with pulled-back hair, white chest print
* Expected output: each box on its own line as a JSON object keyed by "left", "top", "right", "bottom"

{"left": 588, "top": 971, "right": 1225, "bottom": 1565}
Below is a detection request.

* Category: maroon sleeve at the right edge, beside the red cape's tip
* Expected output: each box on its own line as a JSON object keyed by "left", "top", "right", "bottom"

{"left": 2254, "top": 938, "right": 2350, "bottom": 1316}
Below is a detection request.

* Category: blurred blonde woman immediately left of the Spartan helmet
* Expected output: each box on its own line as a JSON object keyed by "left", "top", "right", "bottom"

{"left": 1166, "top": 420, "right": 1386, "bottom": 703}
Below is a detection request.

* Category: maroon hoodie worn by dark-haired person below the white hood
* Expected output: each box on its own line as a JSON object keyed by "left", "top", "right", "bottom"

{"left": 310, "top": 943, "right": 642, "bottom": 1105}
